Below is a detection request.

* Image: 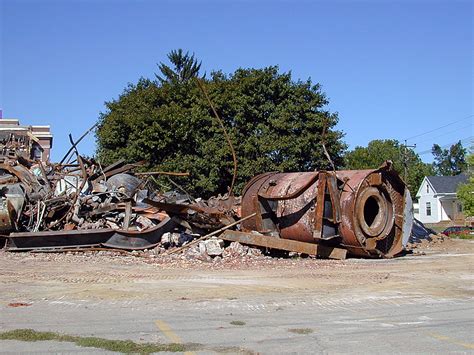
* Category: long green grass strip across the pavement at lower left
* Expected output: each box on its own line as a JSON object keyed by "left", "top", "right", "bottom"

{"left": 0, "top": 329, "right": 193, "bottom": 354}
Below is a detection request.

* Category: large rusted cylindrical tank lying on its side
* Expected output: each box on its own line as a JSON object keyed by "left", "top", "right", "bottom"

{"left": 242, "top": 163, "right": 413, "bottom": 257}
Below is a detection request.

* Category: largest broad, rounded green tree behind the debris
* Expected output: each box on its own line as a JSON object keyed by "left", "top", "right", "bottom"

{"left": 97, "top": 58, "right": 345, "bottom": 197}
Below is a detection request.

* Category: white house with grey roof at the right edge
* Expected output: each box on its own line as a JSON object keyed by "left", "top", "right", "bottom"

{"left": 414, "top": 174, "right": 468, "bottom": 223}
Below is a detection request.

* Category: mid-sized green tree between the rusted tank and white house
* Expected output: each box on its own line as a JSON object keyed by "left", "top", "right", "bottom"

{"left": 344, "top": 139, "right": 434, "bottom": 193}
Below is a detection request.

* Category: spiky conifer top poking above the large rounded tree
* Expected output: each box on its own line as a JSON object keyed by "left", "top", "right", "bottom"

{"left": 155, "top": 49, "right": 201, "bottom": 83}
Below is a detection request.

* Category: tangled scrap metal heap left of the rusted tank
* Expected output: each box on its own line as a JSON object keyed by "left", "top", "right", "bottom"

{"left": 0, "top": 149, "right": 243, "bottom": 250}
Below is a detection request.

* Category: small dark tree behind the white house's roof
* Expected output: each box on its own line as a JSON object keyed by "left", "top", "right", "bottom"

{"left": 431, "top": 141, "right": 467, "bottom": 176}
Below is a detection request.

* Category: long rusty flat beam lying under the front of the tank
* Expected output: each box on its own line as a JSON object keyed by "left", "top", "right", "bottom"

{"left": 219, "top": 230, "right": 347, "bottom": 260}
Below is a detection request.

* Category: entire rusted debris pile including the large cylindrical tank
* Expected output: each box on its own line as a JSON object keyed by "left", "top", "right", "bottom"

{"left": 0, "top": 140, "right": 413, "bottom": 259}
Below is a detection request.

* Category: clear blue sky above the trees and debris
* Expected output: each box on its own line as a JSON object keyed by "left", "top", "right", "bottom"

{"left": 0, "top": 0, "right": 474, "bottom": 161}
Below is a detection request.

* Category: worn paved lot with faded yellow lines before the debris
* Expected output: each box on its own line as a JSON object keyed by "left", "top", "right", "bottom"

{"left": 0, "top": 241, "right": 474, "bottom": 354}
